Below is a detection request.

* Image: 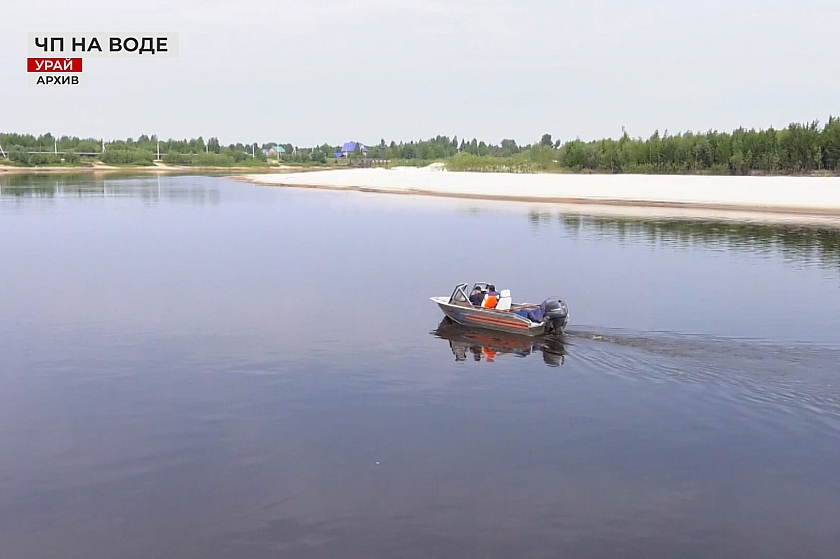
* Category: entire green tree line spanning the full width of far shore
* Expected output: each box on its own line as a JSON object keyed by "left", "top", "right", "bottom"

{"left": 0, "top": 117, "right": 840, "bottom": 175}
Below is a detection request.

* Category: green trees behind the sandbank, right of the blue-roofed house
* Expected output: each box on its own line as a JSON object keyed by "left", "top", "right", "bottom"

{"left": 376, "top": 117, "right": 840, "bottom": 175}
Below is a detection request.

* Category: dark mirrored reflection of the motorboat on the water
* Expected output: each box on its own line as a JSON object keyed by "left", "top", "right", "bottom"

{"left": 432, "top": 318, "right": 566, "bottom": 367}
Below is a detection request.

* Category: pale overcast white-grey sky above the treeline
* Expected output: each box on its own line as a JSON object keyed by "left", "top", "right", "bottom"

{"left": 0, "top": 0, "right": 840, "bottom": 146}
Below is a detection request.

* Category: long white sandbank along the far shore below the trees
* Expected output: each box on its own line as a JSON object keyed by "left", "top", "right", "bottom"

{"left": 234, "top": 166, "right": 840, "bottom": 224}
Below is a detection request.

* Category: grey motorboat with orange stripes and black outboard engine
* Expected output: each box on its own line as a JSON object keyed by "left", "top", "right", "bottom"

{"left": 430, "top": 282, "right": 569, "bottom": 336}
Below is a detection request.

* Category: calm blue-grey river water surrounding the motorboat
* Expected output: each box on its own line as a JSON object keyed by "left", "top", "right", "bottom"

{"left": 0, "top": 176, "right": 840, "bottom": 559}
